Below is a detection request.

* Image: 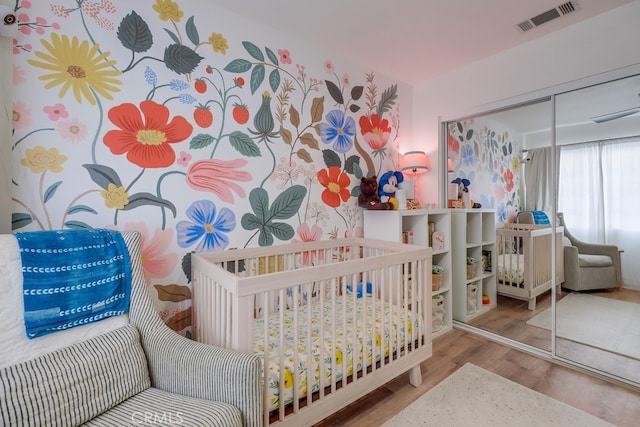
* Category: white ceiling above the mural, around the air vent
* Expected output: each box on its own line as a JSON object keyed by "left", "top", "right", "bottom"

{"left": 208, "top": 0, "right": 635, "bottom": 84}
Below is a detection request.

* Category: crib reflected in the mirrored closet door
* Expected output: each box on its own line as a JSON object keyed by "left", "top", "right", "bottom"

{"left": 496, "top": 224, "right": 564, "bottom": 310}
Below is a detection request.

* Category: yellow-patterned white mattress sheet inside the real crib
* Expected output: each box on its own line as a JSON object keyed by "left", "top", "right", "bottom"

{"left": 253, "top": 295, "right": 427, "bottom": 410}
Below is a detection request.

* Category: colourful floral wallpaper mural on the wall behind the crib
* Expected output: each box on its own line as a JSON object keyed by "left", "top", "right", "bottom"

{"left": 11, "top": 0, "right": 400, "bottom": 333}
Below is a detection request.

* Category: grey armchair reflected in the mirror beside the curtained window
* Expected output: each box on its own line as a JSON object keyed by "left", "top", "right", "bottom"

{"left": 558, "top": 212, "right": 621, "bottom": 291}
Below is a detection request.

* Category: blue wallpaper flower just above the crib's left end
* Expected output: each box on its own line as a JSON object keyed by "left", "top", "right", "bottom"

{"left": 176, "top": 200, "right": 236, "bottom": 252}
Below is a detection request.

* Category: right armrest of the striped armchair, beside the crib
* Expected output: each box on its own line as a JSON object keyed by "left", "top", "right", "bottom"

{"left": 143, "top": 324, "right": 263, "bottom": 426}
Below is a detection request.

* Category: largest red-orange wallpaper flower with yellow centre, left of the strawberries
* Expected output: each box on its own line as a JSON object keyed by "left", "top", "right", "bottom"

{"left": 103, "top": 101, "right": 193, "bottom": 168}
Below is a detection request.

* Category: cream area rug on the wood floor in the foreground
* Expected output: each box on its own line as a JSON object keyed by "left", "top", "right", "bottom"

{"left": 384, "top": 363, "right": 612, "bottom": 427}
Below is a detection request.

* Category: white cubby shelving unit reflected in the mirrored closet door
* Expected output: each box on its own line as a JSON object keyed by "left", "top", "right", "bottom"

{"left": 450, "top": 209, "right": 497, "bottom": 323}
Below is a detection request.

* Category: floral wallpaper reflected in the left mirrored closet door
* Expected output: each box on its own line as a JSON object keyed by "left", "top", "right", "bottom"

{"left": 447, "top": 119, "right": 522, "bottom": 223}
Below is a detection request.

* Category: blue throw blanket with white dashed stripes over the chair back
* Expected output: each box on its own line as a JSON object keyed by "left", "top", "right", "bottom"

{"left": 14, "top": 229, "right": 131, "bottom": 338}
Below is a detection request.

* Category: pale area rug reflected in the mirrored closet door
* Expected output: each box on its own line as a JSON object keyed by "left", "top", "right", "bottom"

{"left": 527, "top": 292, "right": 640, "bottom": 360}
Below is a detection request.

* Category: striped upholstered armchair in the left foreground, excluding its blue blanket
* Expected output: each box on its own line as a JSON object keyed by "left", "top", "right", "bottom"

{"left": 0, "top": 232, "right": 262, "bottom": 426}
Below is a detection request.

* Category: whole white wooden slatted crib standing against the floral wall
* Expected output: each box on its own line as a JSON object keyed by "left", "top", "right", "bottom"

{"left": 191, "top": 238, "right": 432, "bottom": 426}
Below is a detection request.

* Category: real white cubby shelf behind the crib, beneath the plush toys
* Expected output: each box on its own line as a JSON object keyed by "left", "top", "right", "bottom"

{"left": 363, "top": 209, "right": 453, "bottom": 338}
